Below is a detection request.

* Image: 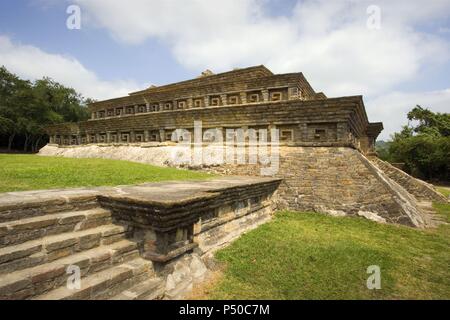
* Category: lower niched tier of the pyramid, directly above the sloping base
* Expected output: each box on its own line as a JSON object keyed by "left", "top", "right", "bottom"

{"left": 47, "top": 96, "right": 382, "bottom": 152}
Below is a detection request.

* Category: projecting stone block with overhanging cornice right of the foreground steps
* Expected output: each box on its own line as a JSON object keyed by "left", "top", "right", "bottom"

{"left": 98, "top": 177, "right": 280, "bottom": 262}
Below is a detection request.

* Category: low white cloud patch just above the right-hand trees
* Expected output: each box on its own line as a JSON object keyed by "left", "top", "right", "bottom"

{"left": 365, "top": 88, "right": 450, "bottom": 140}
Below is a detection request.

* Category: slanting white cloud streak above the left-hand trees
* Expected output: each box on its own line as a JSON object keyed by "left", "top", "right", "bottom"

{"left": 0, "top": 35, "right": 142, "bottom": 99}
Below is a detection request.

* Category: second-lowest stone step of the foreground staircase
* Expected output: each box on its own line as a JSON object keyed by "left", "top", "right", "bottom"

{"left": 33, "top": 258, "right": 154, "bottom": 300}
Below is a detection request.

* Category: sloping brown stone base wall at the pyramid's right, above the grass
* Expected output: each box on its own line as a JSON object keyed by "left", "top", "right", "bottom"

{"left": 207, "top": 147, "right": 424, "bottom": 227}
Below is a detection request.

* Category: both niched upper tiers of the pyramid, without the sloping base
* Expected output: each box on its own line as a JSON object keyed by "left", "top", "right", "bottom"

{"left": 44, "top": 66, "right": 383, "bottom": 152}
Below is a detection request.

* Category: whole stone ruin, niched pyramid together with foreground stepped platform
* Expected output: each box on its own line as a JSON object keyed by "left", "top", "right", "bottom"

{"left": 0, "top": 66, "right": 446, "bottom": 300}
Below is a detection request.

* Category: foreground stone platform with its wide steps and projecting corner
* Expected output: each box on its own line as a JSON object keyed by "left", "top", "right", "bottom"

{"left": 0, "top": 177, "right": 280, "bottom": 300}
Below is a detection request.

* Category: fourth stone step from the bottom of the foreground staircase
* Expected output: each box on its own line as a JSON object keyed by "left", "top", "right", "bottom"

{"left": 0, "top": 224, "right": 127, "bottom": 274}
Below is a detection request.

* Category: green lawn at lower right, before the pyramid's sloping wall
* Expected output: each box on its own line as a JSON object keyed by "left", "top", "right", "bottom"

{"left": 207, "top": 204, "right": 450, "bottom": 299}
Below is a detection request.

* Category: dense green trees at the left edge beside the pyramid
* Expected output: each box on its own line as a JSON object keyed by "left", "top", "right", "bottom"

{"left": 0, "top": 67, "right": 90, "bottom": 152}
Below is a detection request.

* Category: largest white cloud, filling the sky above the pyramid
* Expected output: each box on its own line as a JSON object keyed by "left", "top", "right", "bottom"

{"left": 76, "top": 0, "right": 450, "bottom": 96}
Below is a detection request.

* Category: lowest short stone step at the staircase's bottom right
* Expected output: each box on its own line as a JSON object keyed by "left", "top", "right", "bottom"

{"left": 110, "top": 278, "right": 165, "bottom": 300}
